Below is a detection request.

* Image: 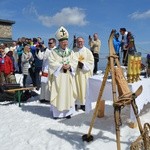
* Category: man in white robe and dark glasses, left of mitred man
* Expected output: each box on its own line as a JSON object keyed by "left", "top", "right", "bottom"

{"left": 36, "top": 38, "right": 56, "bottom": 103}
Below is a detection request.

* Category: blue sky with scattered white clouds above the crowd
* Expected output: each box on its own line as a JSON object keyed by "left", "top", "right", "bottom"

{"left": 0, "top": 0, "right": 150, "bottom": 54}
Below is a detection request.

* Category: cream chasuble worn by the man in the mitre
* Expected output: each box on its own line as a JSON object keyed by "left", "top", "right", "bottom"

{"left": 49, "top": 49, "right": 78, "bottom": 111}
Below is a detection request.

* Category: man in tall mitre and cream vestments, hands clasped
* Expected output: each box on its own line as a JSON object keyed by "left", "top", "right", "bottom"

{"left": 49, "top": 26, "right": 78, "bottom": 119}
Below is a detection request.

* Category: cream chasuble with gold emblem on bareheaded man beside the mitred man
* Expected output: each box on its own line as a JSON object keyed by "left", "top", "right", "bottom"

{"left": 74, "top": 47, "right": 94, "bottom": 105}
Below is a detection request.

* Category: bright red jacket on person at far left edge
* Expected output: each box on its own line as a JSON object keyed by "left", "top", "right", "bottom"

{"left": 0, "top": 55, "right": 14, "bottom": 75}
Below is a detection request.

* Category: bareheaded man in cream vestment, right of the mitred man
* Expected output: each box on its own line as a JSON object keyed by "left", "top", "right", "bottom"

{"left": 74, "top": 37, "right": 94, "bottom": 111}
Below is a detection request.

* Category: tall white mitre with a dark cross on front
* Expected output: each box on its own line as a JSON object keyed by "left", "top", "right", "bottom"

{"left": 55, "top": 26, "right": 69, "bottom": 41}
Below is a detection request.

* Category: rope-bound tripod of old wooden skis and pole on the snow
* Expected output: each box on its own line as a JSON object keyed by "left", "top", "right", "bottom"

{"left": 82, "top": 30, "right": 146, "bottom": 150}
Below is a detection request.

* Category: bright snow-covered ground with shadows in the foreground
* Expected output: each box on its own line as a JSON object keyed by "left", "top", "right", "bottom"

{"left": 0, "top": 74, "right": 150, "bottom": 150}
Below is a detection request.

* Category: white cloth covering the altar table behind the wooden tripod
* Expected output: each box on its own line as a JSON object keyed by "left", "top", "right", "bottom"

{"left": 85, "top": 75, "right": 150, "bottom": 122}
